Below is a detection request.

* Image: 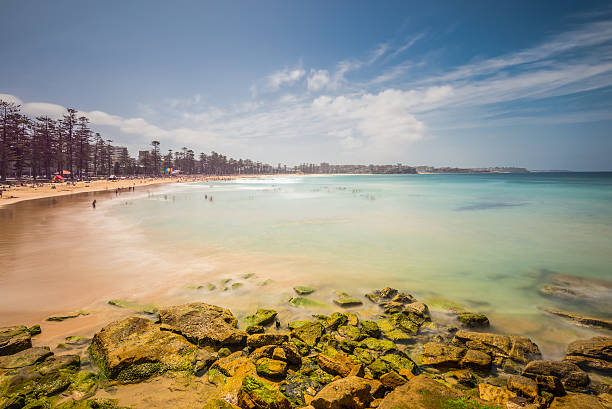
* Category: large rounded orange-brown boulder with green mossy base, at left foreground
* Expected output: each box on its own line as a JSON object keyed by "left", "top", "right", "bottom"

{"left": 89, "top": 317, "right": 197, "bottom": 383}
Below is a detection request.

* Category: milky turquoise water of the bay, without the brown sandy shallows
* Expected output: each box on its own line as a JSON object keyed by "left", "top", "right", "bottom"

{"left": 111, "top": 173, "right": 612, "bottom": 326}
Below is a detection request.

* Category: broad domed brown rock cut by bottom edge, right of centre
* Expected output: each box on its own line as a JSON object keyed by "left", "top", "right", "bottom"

{"left": 378, "top": 375, "right": 462, "bottom": 409}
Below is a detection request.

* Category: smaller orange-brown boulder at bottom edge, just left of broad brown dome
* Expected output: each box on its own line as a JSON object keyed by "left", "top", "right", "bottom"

{"left": 310, "top": 376, "right": 374, "bottom": 409}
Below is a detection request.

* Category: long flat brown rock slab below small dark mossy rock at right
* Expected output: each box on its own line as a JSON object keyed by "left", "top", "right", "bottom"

{"left": 453, "top": 330, "right": 542, "bottom": 363}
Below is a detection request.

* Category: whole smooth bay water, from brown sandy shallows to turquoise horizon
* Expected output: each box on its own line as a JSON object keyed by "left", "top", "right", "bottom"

{"left": 0, "top": 173, "right": 612, "bottom": 357}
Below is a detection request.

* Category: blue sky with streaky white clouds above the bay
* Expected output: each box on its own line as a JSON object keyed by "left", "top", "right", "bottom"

{"left": 0, "top": 0, "right": 612, "bottom": 170}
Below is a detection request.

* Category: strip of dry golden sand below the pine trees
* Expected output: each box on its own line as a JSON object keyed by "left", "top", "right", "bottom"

{"left": 0, "top": 174, "right": 294, "bottom": 208}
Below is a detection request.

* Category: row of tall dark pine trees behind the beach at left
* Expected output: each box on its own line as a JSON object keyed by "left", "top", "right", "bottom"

{"left": 0, "top": 100, "right": 280, "bottom": 181}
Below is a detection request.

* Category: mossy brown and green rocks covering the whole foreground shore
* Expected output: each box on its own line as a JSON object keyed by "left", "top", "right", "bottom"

{"left": 0, "top": 287, "right": 612, "bottom": 409}
